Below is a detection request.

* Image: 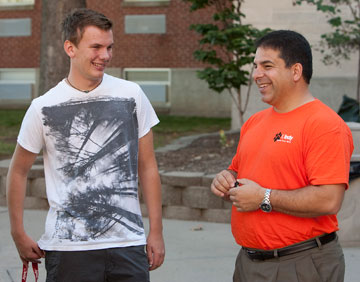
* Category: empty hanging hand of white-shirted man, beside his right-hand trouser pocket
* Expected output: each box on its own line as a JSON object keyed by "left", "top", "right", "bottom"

{"left": 146, "top": 232, "right": 165, "bottom": 271}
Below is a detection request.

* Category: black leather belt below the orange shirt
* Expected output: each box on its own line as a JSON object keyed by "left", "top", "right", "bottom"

{"left": 243, "top": 232, "right": 337, "bottom": 260}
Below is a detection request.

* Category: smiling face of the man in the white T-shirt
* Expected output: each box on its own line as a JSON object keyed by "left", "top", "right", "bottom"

{"left": 72, "top": 26, "right": 114, "bottom": 82}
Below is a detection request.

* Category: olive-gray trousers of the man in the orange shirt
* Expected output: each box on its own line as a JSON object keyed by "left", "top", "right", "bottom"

{"left": 233, "top": 239, "right": 345, "bottom": 282}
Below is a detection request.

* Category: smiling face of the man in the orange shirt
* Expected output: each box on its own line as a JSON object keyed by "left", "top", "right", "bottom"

{"left": 253, "top": 47, "right": 294, "bottom": 109}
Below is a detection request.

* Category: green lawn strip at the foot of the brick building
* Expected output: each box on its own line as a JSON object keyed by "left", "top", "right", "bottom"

{"left": 0, "top": 110, "right": 230, "bottom": 156}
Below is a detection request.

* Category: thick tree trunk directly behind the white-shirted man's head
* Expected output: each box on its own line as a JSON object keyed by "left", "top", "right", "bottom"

{"left": 39, "top": 0, "right": 86, "bottom": 95}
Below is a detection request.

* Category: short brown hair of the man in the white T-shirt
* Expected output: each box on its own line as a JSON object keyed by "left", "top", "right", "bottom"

{"left": 61, "top": 8, "right": 112, "bottom": 46}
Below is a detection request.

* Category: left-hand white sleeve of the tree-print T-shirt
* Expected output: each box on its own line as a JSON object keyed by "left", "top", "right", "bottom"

{"left": 17, "top": 103, "right": 44, "bottom": 154}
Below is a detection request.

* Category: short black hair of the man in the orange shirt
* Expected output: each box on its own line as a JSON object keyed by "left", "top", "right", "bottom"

{"left": 256, "top": 30, "right": 313, "bottom": 84}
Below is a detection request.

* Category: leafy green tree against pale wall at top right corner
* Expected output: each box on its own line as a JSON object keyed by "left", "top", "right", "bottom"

{"left": 293, "top": 0, "right": 360, "bottom": 102}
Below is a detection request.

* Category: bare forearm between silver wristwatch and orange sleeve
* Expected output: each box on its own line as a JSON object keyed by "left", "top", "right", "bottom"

{"left": 270, "top": 184, "right": 345, "bottom": 217}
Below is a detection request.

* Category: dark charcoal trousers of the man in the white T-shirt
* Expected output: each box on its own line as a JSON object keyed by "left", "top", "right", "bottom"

{"left": 45, "top": 246, "right": 150, "bottom": 282}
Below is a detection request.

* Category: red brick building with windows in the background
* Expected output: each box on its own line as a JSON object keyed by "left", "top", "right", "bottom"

{"left": 0, "top": 0, "right": 230, "bottom": 116}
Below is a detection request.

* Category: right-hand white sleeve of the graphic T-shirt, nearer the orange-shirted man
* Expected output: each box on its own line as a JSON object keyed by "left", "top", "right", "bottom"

{"left": 137, "top": 86, "right": 159, "bottom": 138}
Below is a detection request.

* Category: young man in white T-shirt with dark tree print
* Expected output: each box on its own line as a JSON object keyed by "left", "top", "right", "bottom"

{"left": 7, "top": 9, "right": 165, "bottom": 282}
